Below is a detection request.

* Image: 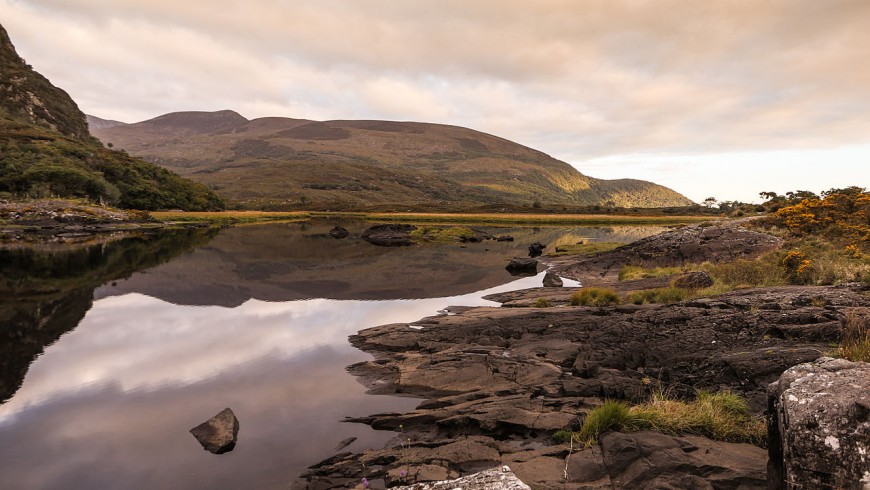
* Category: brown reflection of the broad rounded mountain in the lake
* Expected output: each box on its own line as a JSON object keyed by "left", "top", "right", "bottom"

{"left": 96, "top": 221, "right": 664, "bottom": 306}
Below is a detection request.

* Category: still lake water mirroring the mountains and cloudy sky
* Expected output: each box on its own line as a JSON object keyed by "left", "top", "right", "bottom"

{"left": 0, "top": 222, "right": 662, "bottom": 489}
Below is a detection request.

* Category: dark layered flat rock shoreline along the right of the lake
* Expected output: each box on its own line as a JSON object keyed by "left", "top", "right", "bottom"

{"left": 294, "top": 224, "right": 870, "bottom": 489}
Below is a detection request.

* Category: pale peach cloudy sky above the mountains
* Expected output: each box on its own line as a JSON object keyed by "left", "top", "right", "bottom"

{"left": 0, "top": 0, "right": 870, "bottom": 201}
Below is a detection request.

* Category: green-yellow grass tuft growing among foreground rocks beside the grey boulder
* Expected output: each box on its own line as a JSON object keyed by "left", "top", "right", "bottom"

{"left": 557, "top": 391, "right": 766, "bottom": 447}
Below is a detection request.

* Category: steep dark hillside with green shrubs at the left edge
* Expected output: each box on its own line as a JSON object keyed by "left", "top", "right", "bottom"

{"left": 0, "top": 26, "right": 223, "bottom": 210}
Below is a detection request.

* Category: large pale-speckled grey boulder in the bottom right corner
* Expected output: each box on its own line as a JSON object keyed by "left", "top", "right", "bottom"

{"left": 767, "top": 357, "right": 870, "bottom": 490}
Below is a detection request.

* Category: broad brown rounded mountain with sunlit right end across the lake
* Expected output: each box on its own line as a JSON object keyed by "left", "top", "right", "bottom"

{"left": 91, "top": 110, "right": 692, "bottom": 210}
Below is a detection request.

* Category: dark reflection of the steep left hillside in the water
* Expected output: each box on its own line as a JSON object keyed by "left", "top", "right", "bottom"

{"left": 0, "top": 229, "right": 217, "bottom": 401}
